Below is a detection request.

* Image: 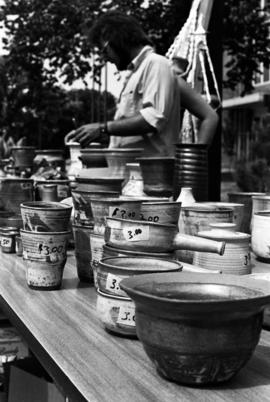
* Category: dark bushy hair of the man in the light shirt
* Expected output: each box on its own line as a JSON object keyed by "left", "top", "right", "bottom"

{"left": 89, "top": 11, "right": 152, "bottom": 49}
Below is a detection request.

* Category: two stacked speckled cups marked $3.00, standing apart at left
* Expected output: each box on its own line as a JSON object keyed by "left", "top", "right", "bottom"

{"left": 21, "top": 201, "right": 72, "bottom": 290}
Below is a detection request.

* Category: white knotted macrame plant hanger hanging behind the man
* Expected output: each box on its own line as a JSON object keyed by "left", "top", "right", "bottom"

{"left": 166, "top": 0, "right": 221, "bottom": 143}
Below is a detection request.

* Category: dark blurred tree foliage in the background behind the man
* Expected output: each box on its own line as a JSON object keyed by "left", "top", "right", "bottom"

{"left": 0, "top": 0, "right": 269, "bottom": 148}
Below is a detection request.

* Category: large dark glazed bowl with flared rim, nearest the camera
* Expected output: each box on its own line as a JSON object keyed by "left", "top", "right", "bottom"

{"left": 120, "top": 272, "right": 270, "bottom": 385}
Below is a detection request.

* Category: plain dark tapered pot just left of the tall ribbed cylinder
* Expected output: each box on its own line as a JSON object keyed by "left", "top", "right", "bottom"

{"left": 137, "top": 156, "right": 174, "bottom": 197}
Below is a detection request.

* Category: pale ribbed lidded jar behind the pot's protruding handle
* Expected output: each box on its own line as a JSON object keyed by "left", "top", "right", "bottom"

{"left": 193, "top": 223, "right": 251, "bottom": 275}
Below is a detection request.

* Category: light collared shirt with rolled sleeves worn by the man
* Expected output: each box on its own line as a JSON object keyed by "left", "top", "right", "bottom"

{"left": 110, "top": 46, "right": 180, "bottom": 155}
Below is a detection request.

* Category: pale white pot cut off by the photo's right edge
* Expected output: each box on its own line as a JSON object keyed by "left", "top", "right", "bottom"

{"left": 251, "top": 210, "right": 270, "bottom": 263}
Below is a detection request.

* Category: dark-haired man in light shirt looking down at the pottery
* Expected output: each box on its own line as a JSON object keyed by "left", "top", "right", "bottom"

{"left": 66, "top": 12, "right": 180, "bottom": 155}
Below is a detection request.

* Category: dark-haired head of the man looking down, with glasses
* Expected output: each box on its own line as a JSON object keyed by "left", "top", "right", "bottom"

{"left": 89, "top": 11, "right": 151, "bottom": 70}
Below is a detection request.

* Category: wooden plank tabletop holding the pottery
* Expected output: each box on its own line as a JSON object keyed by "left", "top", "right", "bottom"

{"left": 0, "top": 254, "right": 270, "bottom": 402}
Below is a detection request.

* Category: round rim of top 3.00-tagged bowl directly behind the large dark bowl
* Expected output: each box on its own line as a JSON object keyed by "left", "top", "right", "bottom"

{"left": 99, "top": 256, "right": 183, "bottom": 275}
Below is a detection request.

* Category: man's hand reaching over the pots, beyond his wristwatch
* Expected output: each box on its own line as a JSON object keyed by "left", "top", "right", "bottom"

{"left": 65, "top": 123, "right": 100, "bottom": 148}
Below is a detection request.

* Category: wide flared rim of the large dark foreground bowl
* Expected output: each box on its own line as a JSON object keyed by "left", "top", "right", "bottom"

{"left": 120, "top": 272, "right": 270, "bottom": 314}
